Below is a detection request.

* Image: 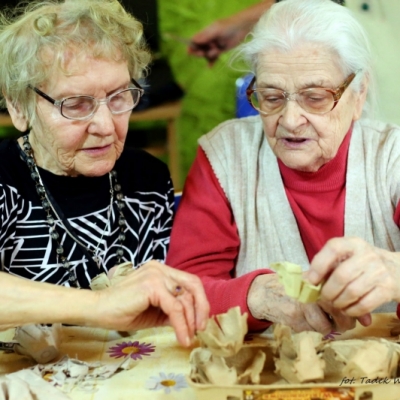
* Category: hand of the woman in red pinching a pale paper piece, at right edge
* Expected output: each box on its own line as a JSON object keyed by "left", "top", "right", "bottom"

{"left": 307, "top": 237, "right": 400, "bottom": 325}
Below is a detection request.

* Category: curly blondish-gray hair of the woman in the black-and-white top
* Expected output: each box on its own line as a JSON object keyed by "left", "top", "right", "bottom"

{"left": 0, "top": 0, "right": 151, "bottom": 122}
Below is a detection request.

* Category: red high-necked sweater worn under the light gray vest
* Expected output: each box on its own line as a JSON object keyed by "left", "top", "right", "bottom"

{"left": 166, "top": 133, "right": 400, "bottom": 331}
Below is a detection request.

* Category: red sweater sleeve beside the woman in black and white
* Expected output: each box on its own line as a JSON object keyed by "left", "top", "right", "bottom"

{"left": 167, "top": 148, "right": 272, "bottom": 331}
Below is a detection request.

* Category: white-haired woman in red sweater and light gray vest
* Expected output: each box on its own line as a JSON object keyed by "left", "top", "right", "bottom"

{"left": 167, "top": 0, "right": 400, "bottom": 333}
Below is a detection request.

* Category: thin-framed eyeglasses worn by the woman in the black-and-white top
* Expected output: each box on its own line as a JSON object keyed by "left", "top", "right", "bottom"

{"left": 28, "top": 78, "right": 144, "bottom": 121}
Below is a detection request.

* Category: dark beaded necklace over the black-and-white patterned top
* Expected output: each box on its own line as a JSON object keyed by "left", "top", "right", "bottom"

{"left": 23, "top": 135, "right": 126, "bottom": 288}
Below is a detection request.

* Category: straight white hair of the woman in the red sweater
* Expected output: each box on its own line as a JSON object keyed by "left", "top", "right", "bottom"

{"left": 235, "top": 0, "right": 377, "bottom": 116}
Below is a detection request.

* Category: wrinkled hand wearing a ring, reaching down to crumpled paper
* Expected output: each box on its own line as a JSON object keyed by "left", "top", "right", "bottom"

{"left": 94, "top": 261, "right": 209, "bottom": 346}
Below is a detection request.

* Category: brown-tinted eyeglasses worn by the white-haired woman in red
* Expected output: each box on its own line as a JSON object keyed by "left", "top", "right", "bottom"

{"left": 246, "top": 73, "right": 356, "bottom": 115}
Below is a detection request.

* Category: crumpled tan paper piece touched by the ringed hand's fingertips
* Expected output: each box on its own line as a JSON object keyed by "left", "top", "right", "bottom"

{"left": 197, "top": 307, "right": 247, "bottom": 357}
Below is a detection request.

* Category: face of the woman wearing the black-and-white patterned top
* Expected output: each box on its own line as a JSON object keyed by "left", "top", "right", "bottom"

{"left": 30, "top": 57, "right": 130, "bottom": 176}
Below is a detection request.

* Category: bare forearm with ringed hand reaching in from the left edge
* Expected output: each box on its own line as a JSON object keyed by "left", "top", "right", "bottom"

{"left": 0, "top": 261, "right": 209, "bottom": 346}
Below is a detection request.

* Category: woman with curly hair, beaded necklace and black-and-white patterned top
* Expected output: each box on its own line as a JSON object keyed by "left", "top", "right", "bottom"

{"left": 0, "top": 0, "right": 208, "bottom": 345}
